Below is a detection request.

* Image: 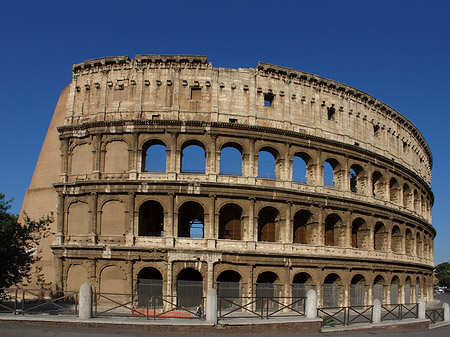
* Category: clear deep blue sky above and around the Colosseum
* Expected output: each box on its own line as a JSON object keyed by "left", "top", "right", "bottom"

{"left": 0, "top": 0, "right": 450, "bottom": 263}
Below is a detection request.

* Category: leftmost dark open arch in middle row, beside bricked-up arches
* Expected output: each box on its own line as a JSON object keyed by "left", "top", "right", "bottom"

{"left": 138, "top": 201, "right": 164, "bottom": 237}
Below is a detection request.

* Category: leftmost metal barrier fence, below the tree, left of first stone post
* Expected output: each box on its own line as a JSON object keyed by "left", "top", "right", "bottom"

{"left": 0, "top": 288, "right": 78, "bottom": 315}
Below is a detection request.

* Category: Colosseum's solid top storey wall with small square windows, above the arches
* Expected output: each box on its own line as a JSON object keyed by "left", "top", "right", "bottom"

{"left": 65, "top": 55, "right": 432, "bottom": 185}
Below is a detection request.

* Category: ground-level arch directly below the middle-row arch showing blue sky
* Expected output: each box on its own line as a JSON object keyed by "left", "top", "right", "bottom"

{"left": 177, "top": 268, "right": 203, "bottom": 308}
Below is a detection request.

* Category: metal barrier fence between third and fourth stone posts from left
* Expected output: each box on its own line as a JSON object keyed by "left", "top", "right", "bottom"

{"left": 317, "top": 305, "right": 373, "bottom": 326}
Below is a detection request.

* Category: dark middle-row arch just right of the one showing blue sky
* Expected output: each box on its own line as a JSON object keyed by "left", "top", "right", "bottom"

{"left": 219, "top": 204, "right": 242, "bottom": 240}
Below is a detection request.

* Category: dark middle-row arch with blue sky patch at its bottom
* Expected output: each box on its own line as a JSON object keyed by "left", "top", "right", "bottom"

{"left": 178, "top": 201, "right": 204, "bottom": 239}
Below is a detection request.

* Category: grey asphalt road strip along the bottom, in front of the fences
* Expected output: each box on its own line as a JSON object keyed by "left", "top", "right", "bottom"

{"left": 0, "top": 323, "right": 450, "bottom": 337}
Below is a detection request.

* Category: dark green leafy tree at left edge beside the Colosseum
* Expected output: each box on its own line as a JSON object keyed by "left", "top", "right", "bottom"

{"left": 0, "top": 193, "right": 53, "bottom": 288}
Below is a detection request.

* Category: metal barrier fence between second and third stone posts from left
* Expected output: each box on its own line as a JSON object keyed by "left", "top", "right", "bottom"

{"left": 218, "top": 297, "right": 306, "bottom": 320}
